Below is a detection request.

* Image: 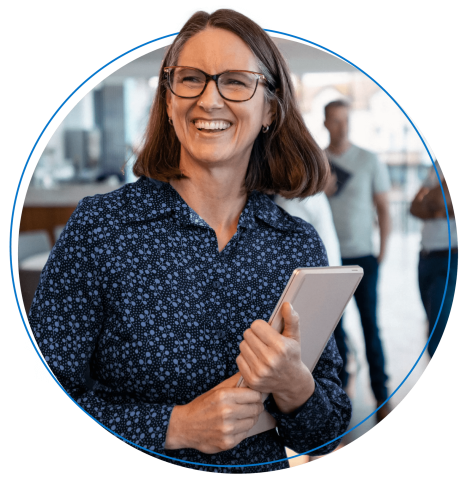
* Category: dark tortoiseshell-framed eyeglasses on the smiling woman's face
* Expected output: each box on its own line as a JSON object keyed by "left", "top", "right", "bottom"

{"left": 164, "top": 66, "right": 266, "bottom": 102}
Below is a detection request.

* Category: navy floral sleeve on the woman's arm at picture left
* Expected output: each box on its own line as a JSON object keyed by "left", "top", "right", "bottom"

{"left": 28, "top": 197, "right": 174, "bottom": 451}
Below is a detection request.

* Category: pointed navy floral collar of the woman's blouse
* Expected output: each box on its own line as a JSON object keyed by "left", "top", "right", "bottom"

{"left": 120, "top": 176, "right": 305, "bottom": 231}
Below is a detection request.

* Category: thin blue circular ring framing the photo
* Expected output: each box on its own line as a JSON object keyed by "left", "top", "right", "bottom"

{"left": 9, "top": 28, "right": 451, "bottom": 468}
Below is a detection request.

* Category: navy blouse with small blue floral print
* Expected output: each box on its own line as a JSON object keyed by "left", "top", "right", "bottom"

{"left": 28, "top": 177, "right": 351, "bottom": 473}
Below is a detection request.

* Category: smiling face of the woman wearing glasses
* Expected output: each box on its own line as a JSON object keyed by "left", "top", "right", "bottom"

{"left": 167, "top": 28, "right": 272, "bottom": 175}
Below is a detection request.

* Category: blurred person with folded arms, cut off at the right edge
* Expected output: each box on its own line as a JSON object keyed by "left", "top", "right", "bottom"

{"left": 410, "top": 161, "right": 459, "bottom": 357}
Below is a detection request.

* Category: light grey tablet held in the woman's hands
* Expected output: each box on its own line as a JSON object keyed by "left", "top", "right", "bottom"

{"left": 237, "top": 265, "right": 363, "bottom": 436}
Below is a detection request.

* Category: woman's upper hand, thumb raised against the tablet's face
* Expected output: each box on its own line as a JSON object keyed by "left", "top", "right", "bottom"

{"left": 237, "top": 303, "right": 315, "bottom": 413}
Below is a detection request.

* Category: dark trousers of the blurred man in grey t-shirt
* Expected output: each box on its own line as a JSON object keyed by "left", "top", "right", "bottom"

{"left": 334, "top": 255, "right": 388, "bottom": 401}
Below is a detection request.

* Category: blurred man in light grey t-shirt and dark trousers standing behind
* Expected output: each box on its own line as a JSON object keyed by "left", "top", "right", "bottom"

{"left": 324, "top": 100, "right": 391, "bottom": 421}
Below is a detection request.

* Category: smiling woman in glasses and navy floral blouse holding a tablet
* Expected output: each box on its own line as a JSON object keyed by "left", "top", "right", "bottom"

{"left": 29, "top": 10, "right": 350, "bottom": 473}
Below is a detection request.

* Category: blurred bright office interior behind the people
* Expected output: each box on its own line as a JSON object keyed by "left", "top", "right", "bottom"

{"left": 18, "top": 36, "right": 449, "bottom": 464}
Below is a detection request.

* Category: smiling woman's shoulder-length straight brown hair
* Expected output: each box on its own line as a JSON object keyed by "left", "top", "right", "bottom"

{"left": 133, "top": 9, "right": 330, "bottom": 198}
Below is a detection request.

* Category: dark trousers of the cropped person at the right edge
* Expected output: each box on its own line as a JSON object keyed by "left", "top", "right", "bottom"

{"left": 418, "top": 250, "right": 459, "bottom": 357}
